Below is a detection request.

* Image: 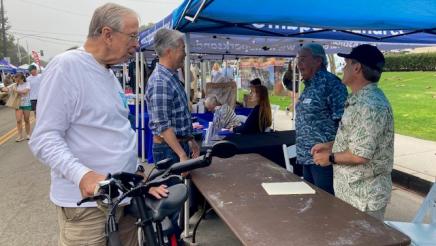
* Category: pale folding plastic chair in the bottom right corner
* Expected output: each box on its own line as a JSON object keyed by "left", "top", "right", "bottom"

{"left": 385, "top": 180, "right": 436, "bottom": 246}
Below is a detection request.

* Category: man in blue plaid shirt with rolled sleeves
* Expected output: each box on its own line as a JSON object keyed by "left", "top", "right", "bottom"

{"left": 145, "top": 29, "right": 200, "bottom": 163}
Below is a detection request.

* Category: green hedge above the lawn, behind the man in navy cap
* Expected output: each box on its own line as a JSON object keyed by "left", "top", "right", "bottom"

{"left": 384, "top": 53, "right": 436, "bottom": 71}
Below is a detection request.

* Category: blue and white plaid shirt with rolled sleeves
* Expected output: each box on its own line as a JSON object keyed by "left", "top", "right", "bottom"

{"left": 145, "top": 63, "right": 192, "bottom": 137}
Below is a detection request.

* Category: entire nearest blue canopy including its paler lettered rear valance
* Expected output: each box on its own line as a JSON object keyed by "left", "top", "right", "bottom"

{"left": 140, "top": 0, "right": 436, "bottom": 56}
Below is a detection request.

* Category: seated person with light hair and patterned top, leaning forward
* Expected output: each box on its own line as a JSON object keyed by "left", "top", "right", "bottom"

{"left": 204, "top": 95, "right": 241, "bottom": 129}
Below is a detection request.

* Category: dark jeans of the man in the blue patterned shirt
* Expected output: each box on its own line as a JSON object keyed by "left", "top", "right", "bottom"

{"left": 303, "top": 165, "right": 335, "bottom": 195}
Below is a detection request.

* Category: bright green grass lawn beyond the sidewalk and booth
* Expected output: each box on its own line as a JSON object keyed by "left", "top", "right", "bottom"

{"left": 238, "top": 72, "right": 436, "bottom": 141}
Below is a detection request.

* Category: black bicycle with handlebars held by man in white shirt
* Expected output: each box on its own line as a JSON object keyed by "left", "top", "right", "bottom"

{"left": 77, "top": 141, "right": 236, "bottom": 246}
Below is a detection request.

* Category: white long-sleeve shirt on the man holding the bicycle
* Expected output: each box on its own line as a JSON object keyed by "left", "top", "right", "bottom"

{"left": 29, "top": 48, "right": 137, "bottom": 207}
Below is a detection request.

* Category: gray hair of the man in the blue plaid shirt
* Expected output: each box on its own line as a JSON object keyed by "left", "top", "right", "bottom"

{"left": 154, "top": 28, "right": 183, "bottom": 56}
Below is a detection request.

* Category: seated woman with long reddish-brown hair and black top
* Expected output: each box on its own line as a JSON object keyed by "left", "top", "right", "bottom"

{"left": 232, "top": 85, "right": 272, "bottom": 134}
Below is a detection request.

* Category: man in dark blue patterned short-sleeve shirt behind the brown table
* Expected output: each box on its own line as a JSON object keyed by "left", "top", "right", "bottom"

{"left": 295, "top": 43, "right": 347, "bottom": 194}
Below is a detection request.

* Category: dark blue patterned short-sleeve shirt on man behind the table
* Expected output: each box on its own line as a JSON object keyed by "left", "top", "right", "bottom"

{"left": 295, "top": 69, "right": 348, "bottom": 165}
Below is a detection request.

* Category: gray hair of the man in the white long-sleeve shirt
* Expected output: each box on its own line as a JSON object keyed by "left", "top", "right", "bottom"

{"left": 88, "top": 3, "right": 138, "bottom": 38}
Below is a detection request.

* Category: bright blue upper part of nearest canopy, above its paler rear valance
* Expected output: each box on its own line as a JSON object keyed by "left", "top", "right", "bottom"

{"left": 173, "top": 0, "right": 436, "bottom": 44}
